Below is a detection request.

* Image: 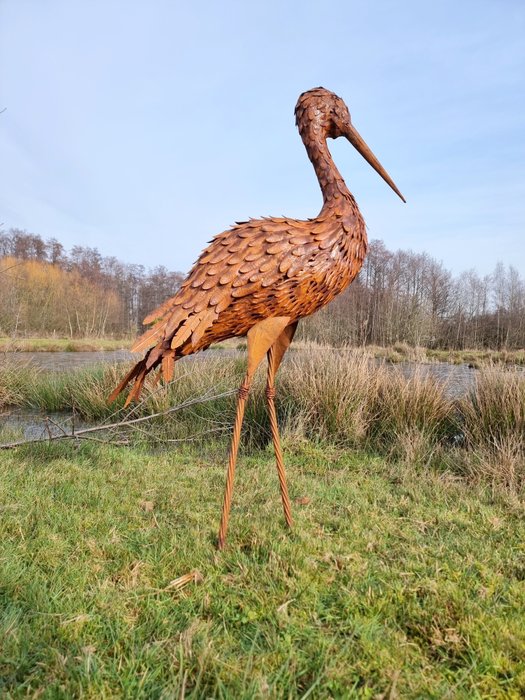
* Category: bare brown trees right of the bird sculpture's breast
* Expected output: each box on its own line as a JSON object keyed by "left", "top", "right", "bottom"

{"left": 302, "top": 241, "right": 525, "bottom": 349}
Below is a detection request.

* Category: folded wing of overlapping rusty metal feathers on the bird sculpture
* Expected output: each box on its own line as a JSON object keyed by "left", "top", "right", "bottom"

{"left": 132, "top": 218, "right": 342, "bottom": 359}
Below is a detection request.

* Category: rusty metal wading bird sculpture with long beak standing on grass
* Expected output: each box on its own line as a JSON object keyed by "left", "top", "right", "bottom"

{"left": 110, "top": 87, "right": 405, "bottom": 549}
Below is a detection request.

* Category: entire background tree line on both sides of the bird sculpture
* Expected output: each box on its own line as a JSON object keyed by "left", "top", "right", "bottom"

{"left": 0, "top": 229, "right": 525, "bottom": 349}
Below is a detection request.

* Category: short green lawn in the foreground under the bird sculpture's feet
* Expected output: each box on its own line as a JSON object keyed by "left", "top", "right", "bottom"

{"left": 0, "top": 439, "right": 525, "bottom": 699}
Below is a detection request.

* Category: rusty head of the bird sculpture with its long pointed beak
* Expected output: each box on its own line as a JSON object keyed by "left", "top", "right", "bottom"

{"left": 295, "top": 87, "right": 406, "bottom": 202}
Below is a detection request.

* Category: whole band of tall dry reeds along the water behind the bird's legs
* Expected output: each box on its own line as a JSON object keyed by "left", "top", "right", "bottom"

{"left": 4, "top": 344, "right": 525, "bottom": 493}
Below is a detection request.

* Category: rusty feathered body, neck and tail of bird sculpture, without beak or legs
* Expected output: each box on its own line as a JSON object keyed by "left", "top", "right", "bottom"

{"left": 110, "top": 89, "right": 367, "bottom": 403}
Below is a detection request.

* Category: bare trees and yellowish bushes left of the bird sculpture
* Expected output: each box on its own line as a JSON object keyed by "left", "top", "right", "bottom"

{"left": 0, "top": 229, "right": 183, "bottom": 337}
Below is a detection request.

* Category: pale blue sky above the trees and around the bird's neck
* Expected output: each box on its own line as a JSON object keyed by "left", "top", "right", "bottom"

{"left": 0, "top": 0, "right": 525, "bottom": 274}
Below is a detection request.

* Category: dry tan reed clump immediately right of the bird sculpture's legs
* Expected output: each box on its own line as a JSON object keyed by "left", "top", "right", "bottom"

{"left": 280, "top": 348, "right": 454, "bottom": 461}
